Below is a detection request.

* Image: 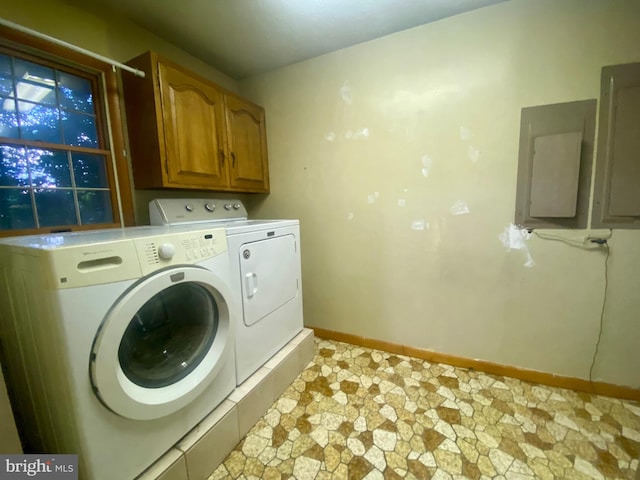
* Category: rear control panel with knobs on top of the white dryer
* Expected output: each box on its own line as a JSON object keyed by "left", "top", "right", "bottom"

{"left": 149, "top": 198, "right": 248, "bottom": 225}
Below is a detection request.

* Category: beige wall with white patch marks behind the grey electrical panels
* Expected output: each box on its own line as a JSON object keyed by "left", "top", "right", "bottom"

{"left": 241, "top": 0, "right": 640, "bottom": 387}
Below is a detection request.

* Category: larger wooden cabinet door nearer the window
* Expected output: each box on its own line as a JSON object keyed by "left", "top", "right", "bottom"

{"left": 158, "top": 63, "right": 228, "bottom": 188}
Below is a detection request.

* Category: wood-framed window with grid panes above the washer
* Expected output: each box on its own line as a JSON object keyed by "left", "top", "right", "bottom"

{"left": 0, "top": 26, "right": 133, "bottom": 236}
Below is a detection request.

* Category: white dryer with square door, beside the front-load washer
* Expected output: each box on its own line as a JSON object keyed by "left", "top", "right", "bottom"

{"left": 149, "top": 199, "right": 303, "bottom": 385}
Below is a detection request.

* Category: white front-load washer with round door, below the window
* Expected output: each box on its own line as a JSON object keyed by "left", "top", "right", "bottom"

{"left": 0, "top": 226, "right": 240, "bottom": 480}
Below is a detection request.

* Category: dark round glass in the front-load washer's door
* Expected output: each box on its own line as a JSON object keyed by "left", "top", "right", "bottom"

{"left": 118, "top": 283, "right": 219, "bottom": 388}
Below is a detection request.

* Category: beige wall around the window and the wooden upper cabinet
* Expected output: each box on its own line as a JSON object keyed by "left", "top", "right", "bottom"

{"left": 0, "top": 0, "right": 238, "bottom": 224}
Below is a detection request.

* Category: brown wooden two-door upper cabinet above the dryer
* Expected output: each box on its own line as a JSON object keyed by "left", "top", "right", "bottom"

{"left": 122, "top": 52, "right": 269, "bottom": 192}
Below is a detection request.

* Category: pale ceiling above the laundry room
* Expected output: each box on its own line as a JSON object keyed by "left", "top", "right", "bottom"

{"left": 83, "top": 0, "right": 505, "bottom": 80}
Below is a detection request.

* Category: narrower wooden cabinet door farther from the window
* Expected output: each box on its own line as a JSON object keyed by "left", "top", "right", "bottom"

{"left": 225, "top": 95, "right": 269, "bottom": 192}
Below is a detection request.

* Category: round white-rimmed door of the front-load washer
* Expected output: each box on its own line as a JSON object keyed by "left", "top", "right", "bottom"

{"left": 90, "top": 266, "right": 233, "bottom": 420}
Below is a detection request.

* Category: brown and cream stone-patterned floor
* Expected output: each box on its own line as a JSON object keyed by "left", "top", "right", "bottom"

{"left": 209, "top": 338, "right": 640, "bottom": 480}
